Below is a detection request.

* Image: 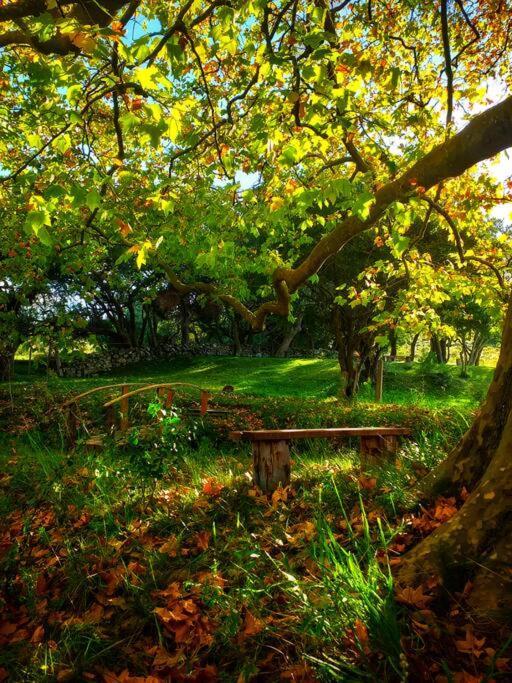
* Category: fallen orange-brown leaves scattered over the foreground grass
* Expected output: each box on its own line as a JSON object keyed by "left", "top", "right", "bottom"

{"left": 0, "top": 440, "right": 510, "bottom": 683}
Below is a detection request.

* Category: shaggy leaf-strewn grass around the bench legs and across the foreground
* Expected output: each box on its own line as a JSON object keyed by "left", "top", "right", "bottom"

{"left": 0, "top": 424, "right": 508, "bottom": 683}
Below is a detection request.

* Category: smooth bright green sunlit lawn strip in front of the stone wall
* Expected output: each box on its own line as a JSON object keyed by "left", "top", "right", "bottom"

{"left": 8, "top": 356, "right": 492, "bottom": 407}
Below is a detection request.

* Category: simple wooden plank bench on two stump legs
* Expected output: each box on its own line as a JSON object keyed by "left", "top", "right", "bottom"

{"left": 230, "top": 427, "right": 411, "bottom": 491}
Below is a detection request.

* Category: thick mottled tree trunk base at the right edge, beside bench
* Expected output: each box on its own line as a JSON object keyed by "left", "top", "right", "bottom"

{"left": 398, "top": 299, "right": 512, "bottom": 616}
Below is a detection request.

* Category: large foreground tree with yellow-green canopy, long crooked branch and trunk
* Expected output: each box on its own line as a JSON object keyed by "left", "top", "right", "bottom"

{"left": 0, "top": 0, "right": 512, "bottom": 620}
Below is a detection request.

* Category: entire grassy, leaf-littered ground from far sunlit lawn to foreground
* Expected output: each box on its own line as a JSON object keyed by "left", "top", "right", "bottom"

{"left": 0, "top": 358, "right": 512, "bottom": 683}
